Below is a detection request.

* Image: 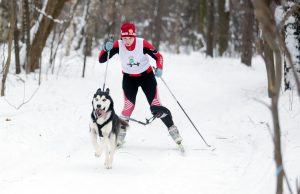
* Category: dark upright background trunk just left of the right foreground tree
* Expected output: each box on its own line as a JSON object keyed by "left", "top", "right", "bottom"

{"left": 241, "top": 0, "right": 254, "bottom": 66}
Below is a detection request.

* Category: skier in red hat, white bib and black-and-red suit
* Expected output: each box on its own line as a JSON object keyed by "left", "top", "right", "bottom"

{"left": 99, "top": 22, "right": 182, "bottom": 145}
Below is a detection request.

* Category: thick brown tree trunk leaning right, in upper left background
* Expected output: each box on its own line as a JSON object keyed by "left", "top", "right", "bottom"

{"left": 27, "top": 0, "right": 67, "bottom": 72}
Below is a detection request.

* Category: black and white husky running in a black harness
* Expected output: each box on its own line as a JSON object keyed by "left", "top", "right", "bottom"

{"left": 90, "top": 88, "right": 128, "bottom": 169}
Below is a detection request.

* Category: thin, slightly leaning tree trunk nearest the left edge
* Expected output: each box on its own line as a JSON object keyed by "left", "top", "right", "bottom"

{"left": 1, "top": 1, "right": 16, "bottom": 96}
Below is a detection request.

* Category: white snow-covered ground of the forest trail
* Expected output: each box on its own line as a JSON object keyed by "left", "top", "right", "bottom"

{"left": 0, "top": 53, "right": 300, "bottom": 194}
